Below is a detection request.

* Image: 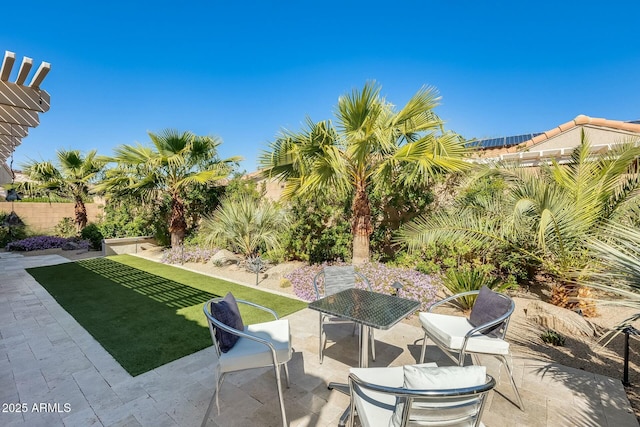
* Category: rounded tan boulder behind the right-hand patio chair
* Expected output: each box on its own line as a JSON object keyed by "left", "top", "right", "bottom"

{"left": 524, "top": 301, "right": 597, "bottom": 337}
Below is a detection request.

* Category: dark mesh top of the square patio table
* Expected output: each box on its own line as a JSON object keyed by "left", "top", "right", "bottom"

{"left": 309, "top": 288, "right": 420, "bottom": 329}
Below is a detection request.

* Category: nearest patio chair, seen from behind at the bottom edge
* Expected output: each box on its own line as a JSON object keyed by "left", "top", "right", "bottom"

{"left": 349, "top": 363, "right": 495, "bottom": 427}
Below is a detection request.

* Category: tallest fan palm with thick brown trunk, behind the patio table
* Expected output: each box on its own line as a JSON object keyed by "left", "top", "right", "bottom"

{"left": 260, "top": 82, "right": 467, "bottom": 264}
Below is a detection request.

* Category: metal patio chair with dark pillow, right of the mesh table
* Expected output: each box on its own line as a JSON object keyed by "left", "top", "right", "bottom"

{"left": 419, "top": 286, "right": 524, "bottom": 411}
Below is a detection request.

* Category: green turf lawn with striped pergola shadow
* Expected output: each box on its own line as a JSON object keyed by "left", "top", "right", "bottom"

{"left": 27, "top": 255, "right": 307, "bottom": 376}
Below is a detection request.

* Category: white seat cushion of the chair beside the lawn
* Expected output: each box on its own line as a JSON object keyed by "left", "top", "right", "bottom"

{"left": 219, "top": 319, "right": 291, "bottom": 372}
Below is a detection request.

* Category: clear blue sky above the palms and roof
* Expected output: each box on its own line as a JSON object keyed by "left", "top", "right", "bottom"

{"left": 0, "top": 0, "right": 640, "bottom": 172}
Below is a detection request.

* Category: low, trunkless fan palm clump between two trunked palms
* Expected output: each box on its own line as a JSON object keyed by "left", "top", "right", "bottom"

{"left": 199, "top": 194, "right": 289, "bottom": 257}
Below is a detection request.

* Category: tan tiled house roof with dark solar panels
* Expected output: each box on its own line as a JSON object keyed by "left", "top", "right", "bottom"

{"left": 469, "top": 115, "right": 640, "bottom": 165}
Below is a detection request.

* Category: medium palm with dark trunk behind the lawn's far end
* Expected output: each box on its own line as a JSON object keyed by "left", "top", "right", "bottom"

{"left": 98, "top": 129, "right": 242, "bottom": 247}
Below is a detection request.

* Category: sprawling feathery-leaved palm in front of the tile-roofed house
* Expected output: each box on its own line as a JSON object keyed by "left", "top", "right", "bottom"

{"left": 399, "top": 134, "right": 640, "bottom": 314}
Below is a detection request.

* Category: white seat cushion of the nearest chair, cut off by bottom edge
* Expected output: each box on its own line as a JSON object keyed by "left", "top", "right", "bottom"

{"left": 349, "top": 363, "right": 436, "bottom": 427}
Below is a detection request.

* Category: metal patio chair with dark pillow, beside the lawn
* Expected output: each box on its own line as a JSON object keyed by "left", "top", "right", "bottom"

{"left": 202, "top": 293, "right": 292, "bottom": 427}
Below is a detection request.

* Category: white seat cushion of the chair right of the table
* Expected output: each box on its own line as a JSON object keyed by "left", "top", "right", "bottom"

{"left": 419, "top": 312, "right": 509, "bottom": 354}
